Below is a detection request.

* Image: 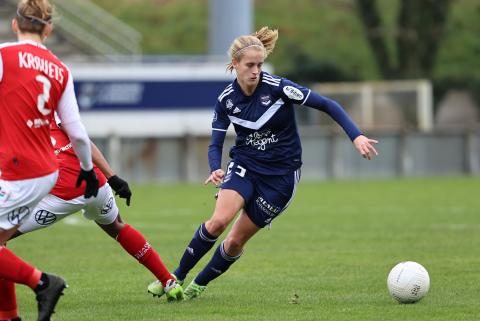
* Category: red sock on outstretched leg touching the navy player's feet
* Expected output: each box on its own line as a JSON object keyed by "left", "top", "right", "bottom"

{"left": 117, "top": 224, "right": 173, "bottom": 286}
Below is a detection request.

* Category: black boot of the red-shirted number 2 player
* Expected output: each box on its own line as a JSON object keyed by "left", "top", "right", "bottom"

{"left": 36, "top": 273, "right": 67, "bottom": 321}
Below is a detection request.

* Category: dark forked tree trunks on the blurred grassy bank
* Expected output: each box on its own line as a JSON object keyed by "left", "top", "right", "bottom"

{"left": 355, "top": 0, "right": 452, "bottom": 79}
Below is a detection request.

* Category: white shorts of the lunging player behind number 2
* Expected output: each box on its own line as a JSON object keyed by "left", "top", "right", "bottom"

{"left": 18, "top": 183, "right": 118, "bottom": 233}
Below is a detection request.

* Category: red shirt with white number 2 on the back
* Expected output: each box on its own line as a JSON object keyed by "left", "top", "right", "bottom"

{"left": 0, "top": 41, "right": 70, "bottom": 180}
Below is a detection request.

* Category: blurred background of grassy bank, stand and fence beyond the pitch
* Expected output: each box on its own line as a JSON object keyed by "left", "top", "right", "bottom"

{"left": 0, "top": 0, "right": 480, "bottom": 183}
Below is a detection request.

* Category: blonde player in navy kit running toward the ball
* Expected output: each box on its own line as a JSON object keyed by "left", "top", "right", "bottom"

{"left": 149, "top": 27, "right": 377, "bottom": 299}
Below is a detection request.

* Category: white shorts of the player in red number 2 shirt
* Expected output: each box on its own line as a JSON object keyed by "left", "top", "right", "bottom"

{"left": 0, "top": 171, "right": 58, "bottom": 230}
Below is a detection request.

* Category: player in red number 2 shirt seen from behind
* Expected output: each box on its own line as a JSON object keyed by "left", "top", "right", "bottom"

{"left": 0, "top": 0, "right": 98, "bottom": 321}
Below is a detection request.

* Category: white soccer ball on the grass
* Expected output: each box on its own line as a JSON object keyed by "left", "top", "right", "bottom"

{"left": 387, "top": 261, "right": 430, "bottom": 303}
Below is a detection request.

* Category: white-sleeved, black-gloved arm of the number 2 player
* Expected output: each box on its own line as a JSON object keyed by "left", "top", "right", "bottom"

{"left": 57, "top": 70, "right": 98, "bottom": 198}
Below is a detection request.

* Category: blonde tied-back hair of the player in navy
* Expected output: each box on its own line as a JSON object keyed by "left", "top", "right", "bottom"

{"left": 227, "top": 27, "right": 278, "bottom": 72}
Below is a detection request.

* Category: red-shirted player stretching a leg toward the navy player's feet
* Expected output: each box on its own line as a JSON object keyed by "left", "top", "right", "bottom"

{"left": 0, "top": 119, "right": 183, "bottom": 313}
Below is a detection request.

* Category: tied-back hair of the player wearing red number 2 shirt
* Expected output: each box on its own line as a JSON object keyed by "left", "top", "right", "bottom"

{"left": 15, "top": 0, "right": 54, "bottom": 34}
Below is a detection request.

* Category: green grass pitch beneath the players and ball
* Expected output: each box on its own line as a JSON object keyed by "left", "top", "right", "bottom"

{"left": 9, "top": 177, "right": 480, "bottom": 321}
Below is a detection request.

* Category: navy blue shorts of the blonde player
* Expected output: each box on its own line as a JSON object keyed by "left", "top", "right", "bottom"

{"left": 221, "top": 161, "right": 300, "bottom": 228}
